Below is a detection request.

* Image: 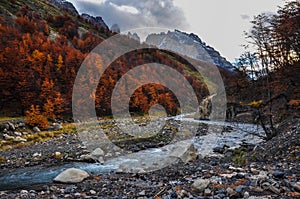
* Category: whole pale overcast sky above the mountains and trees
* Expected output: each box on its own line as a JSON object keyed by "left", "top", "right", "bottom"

{"left": 69, "top": 0, "right": 284, "bottom": 62}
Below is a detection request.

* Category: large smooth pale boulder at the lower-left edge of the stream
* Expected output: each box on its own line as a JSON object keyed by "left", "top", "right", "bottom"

{"left": 54, "top": 168, "right": 90, "bottom": 183}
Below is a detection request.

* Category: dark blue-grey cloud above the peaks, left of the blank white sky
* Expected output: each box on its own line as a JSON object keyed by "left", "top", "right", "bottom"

{"left": 70, "top": 0, "right": 189, "bottom": 31}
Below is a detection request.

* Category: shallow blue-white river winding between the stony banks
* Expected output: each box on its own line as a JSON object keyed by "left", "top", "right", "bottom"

{"left": 0, "top": 115, "right": 263, "bottom": 190}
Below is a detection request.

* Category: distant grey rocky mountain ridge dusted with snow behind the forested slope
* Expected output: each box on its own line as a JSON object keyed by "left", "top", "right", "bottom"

{"left": 146, "top": 30, "right": 234, "bottom": 71}
